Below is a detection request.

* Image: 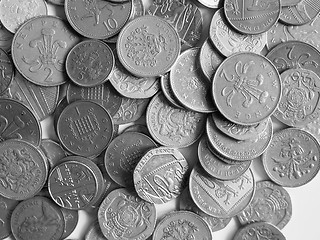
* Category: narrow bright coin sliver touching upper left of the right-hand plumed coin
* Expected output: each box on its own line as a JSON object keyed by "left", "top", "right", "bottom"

{"left": 199, "top": 38, "right": 224, "bottom": 81}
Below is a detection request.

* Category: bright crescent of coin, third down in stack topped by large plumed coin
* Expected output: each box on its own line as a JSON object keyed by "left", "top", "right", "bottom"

{"left": 206, "top": 115, "right": 273, "bottom": 161}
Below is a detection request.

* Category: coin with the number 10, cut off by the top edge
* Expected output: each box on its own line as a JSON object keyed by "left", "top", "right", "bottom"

{"left": 64, "top": 0, "right": 132, "bottom": 39}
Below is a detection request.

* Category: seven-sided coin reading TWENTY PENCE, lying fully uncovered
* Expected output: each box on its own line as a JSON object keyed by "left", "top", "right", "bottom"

{"left": 133, "top": 147, "right": 188, "bottom": 204}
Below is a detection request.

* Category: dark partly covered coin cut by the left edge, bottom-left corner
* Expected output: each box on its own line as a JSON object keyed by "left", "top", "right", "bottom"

{"left": 0, "top": 195, "right": 19, "bottom": 239}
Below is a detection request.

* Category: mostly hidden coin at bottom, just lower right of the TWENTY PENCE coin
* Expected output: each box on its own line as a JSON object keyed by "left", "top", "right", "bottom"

{"left": 179, "top": 187, "right": 231, "bottom": 233}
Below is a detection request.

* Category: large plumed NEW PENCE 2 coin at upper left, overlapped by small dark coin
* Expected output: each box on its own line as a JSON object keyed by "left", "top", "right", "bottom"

{"left": 11, "top": 16, "right": 79, "bottom": 87}
